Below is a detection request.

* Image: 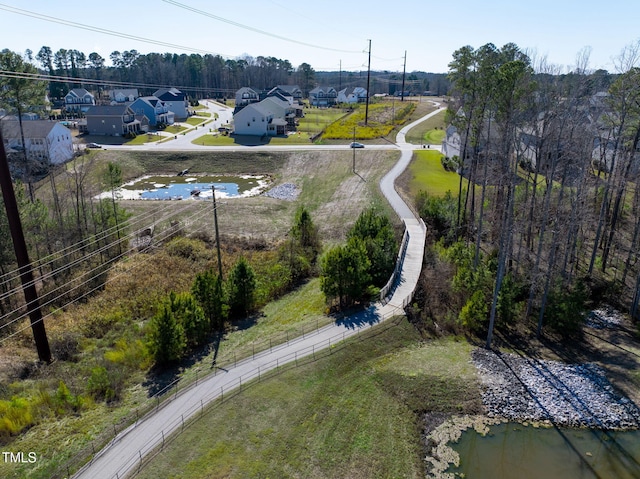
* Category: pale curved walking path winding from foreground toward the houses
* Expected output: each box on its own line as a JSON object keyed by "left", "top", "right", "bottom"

{"left": 74, "top": 108, "right": 442, "bottom": 479}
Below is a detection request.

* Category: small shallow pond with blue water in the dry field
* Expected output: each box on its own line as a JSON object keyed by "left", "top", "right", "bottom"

{"left": 112, "top": 175, "right": 268, "bottom": 200}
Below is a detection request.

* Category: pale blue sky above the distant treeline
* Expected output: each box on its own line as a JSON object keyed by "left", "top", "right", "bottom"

{"left": 0, "top": 0, "right": 640, "bottom": 73}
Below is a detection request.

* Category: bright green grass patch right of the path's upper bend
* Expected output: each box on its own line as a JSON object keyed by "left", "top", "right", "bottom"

{"left": 409, "top": 150, "right": 467, "bottom": 197}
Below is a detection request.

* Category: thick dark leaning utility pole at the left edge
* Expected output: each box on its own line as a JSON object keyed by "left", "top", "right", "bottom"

{"left": 0, "top": 132, "right": 51, "bottom": 363}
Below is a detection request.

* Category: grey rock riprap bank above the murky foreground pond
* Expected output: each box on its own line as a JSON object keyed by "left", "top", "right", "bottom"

{"left": 472, "top": 349, "right": 640, "bottom": 429}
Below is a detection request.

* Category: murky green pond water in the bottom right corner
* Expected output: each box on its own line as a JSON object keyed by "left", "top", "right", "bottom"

{"left": 447, "top": 423, "right": 640, "bottom": 479}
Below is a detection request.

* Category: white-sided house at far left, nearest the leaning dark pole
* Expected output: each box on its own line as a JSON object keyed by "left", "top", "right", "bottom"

{"left": 0, "top": 120, "right": 74, "bottom": 165}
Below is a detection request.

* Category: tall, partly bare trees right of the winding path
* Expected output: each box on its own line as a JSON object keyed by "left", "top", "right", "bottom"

{"left": 418, "top": 40, "right": 640, "bottom": 345}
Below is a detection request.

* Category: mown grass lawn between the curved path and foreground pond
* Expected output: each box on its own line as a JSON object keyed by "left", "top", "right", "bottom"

{"left": 136, "top": 320, "right": 479, "bottom": 479}
